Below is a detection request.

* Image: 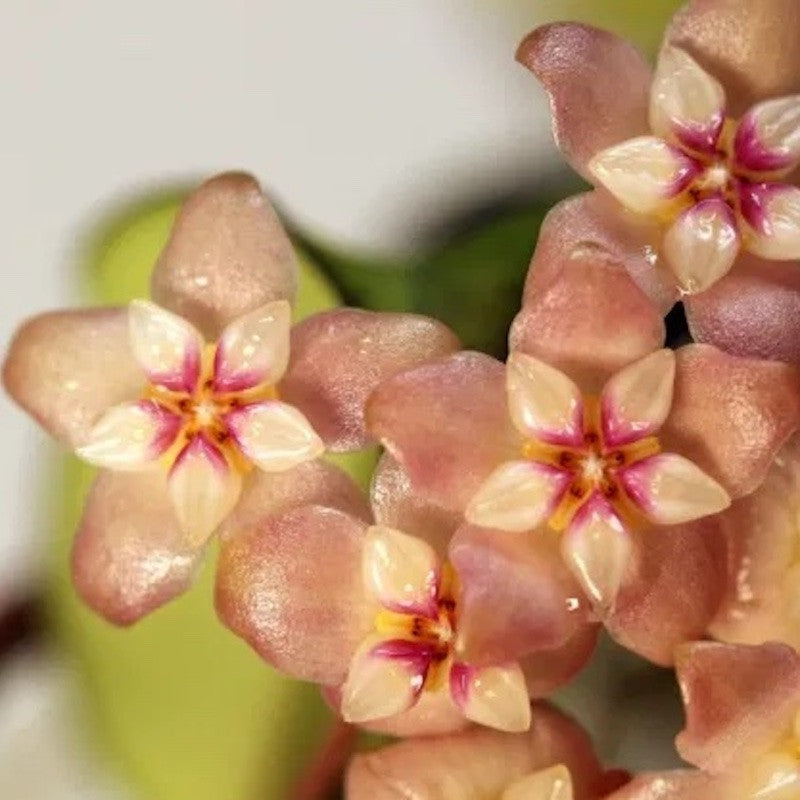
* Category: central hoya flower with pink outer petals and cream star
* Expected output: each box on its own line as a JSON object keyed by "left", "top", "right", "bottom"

{"left": 367, "top": 206, "right": 800, "bottom": 663}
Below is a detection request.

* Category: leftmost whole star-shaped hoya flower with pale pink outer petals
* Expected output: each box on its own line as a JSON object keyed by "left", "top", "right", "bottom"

{"left": 3, "top": 174, "right": 457, "bottom": 624}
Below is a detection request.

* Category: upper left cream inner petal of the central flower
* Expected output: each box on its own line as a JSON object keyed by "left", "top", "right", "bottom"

{"left": 506, "top": 352, "right": 583, "bottom": 445}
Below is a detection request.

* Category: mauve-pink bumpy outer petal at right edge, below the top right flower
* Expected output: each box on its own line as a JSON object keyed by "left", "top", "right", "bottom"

{"left": 684, "top": 254, "right": 800, "bottom": 365}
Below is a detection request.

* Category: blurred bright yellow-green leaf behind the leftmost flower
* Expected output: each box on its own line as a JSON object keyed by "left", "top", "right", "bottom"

{"left": 49, "top": 193, "right": 375, "bottom": 800}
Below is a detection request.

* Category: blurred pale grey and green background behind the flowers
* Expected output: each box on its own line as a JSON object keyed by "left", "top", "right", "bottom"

{"left": 0, "top": 0, "right": 678, "bottom": 800}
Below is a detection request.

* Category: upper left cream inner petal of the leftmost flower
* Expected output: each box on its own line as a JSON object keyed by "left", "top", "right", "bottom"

{"left": 128, "top": 300, "right": 203, "bottom": 392}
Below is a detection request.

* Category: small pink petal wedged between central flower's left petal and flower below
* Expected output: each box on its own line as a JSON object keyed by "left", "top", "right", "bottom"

{"left": 370, "top": 453, "right": 462, "bottom": 556}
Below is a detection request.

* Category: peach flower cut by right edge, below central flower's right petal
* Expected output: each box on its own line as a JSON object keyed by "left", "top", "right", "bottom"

{"left": 710, "top": 436, "right": 800, "bottom": 648}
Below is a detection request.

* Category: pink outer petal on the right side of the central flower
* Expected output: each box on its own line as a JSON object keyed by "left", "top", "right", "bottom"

{"left": 659, "top": 344, "right": 800, "bottom": 498}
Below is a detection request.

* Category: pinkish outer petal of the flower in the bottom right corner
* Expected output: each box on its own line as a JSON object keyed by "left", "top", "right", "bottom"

{"left": 676, "top": 642, "right": 800, "bottom": 774}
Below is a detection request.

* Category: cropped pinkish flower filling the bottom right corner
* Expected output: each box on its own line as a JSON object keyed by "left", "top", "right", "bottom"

{"left": 677, "top": 642, "right": 800, "bottom": 800}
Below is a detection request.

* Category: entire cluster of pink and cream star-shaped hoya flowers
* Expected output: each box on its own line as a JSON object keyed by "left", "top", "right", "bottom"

{"left": 4, "top": 0, "right": 800, "bottom": 800}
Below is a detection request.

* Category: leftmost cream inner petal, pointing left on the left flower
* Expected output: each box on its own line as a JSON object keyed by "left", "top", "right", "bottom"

{"left": 75, "top": 400, "right": 182, "bottom": 470}
